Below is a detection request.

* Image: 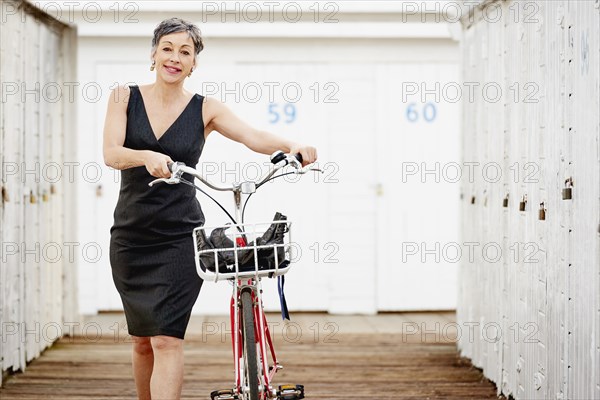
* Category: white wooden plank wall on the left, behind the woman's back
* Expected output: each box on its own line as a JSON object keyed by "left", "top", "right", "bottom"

{"left": 0, "top": 1, "right": 77, "bottom": 384}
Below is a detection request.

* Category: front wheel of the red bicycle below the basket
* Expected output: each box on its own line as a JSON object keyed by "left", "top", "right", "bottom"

{"left": 242, "top": 290, "right": 259, "bottom": 400}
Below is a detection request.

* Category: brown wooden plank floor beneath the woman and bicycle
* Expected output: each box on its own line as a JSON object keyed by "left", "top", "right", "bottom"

{"left": 0, "top": 313, "right": 504, "bottom": 400}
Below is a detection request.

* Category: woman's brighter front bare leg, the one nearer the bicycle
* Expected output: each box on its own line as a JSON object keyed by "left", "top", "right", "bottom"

{"left": 150, "top": 336, "right": 183, "bottom": 400}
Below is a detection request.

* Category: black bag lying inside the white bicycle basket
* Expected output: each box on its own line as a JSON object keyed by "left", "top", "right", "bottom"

{"left": 196, "top": 212, "right": 289, "bottom": 273}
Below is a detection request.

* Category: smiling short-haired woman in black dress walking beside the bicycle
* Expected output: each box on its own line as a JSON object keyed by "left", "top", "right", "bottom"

{"left": 103, "top": 18, "right": 317, "bottom": 399}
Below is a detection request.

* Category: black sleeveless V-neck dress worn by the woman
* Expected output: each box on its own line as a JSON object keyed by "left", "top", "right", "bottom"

{"left": 110, "top": 86, "right": 204, "bottom": 339}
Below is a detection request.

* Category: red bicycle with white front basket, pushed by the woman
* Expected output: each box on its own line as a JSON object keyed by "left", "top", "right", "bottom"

{"left": 149, "top": 151, "right": 322, "bottom": 400}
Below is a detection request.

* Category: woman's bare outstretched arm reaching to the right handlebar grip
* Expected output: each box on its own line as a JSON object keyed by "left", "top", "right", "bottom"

{"left": 203, "top": 98, "right": 317, "bottom": 165}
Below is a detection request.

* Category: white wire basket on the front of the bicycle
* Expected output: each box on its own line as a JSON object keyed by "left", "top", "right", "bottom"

{"left": 192, "top": 220, "right": 293, "bottom": 282}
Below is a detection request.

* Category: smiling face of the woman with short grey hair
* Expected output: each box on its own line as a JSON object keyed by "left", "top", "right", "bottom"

{"left": 154, "top": 32, "right": 196, "bottom": 82}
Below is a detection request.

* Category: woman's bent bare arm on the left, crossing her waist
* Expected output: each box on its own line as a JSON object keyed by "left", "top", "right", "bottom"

{"left": 102, "top": 86, "right": 173, "bottom": 178}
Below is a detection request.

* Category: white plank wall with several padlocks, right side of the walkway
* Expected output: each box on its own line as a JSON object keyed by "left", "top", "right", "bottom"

{"left": 457, "top": 0, "right": 600, "bottom": 399}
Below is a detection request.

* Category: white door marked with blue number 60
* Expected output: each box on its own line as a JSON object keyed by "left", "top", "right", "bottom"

{"left": 377, "top": 63, "right": 464, "bottom": 311}
